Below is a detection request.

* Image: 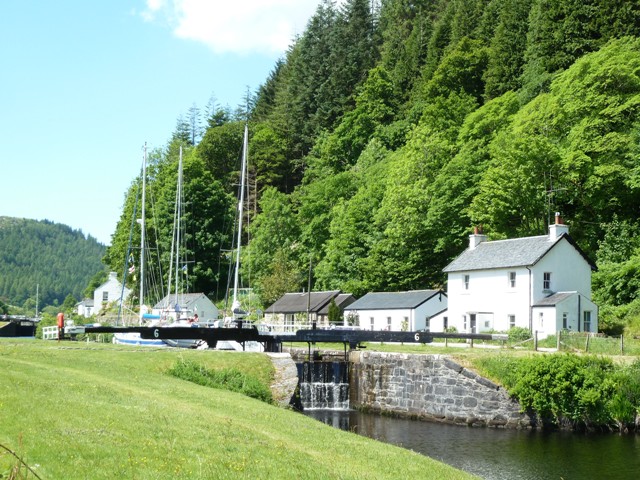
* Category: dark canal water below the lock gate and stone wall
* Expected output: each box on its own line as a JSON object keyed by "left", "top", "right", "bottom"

{"left": 305, "top": 410, "right": 640, "bottom": 480}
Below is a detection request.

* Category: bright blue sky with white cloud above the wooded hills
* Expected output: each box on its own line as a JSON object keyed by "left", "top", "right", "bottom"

{"left": 0, "top": 0, "right": 319, "bottom": 245}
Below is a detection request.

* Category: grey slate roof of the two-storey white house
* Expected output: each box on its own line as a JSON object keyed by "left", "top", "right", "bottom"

{"left": 443, "top": 234, "right": 595, "bottom": 273}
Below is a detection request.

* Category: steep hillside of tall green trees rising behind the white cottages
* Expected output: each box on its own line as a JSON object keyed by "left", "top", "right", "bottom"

{"left": 107, "top": 0, "right": 640, "bottom": 336}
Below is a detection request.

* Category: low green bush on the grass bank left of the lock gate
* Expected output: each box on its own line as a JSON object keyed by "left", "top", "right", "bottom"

{"left": 168, "top": 359, "right": 272, "bottom": 403}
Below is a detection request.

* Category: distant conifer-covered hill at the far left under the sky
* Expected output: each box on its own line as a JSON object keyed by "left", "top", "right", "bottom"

{"left": 0, "top": 217, "right": 106, "bottom": 307}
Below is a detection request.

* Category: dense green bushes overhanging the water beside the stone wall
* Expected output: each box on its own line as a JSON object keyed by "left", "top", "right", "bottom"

{"left": 477, "top": 354, "right": 640, "bottom": 430}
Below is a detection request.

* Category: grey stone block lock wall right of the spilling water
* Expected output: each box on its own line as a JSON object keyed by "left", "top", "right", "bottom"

{"left": 349, "top": 351, "right": 531, "bottom": 428}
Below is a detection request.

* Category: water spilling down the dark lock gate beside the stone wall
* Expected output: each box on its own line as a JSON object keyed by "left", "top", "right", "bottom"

{"left": 297, "top": 362, "right": 349, "bottom": 410}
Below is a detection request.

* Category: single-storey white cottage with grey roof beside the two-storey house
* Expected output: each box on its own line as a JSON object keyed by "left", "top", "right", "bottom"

{"left": 344, "top": 290, "right": 447, "bottom": 331}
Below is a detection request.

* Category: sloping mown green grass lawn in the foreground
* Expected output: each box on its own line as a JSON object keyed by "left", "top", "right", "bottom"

{"left": 0, "top": 339, "right": 473, "bottom": 480}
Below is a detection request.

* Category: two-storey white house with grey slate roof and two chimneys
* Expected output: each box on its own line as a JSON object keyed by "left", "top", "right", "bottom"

{"left": 444, "top": 214, "right": 598, "bottom": 338}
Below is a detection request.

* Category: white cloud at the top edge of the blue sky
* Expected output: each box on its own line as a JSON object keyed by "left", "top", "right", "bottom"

{"left": 141, "top": 0, "right": 319, "bottom": 54}
